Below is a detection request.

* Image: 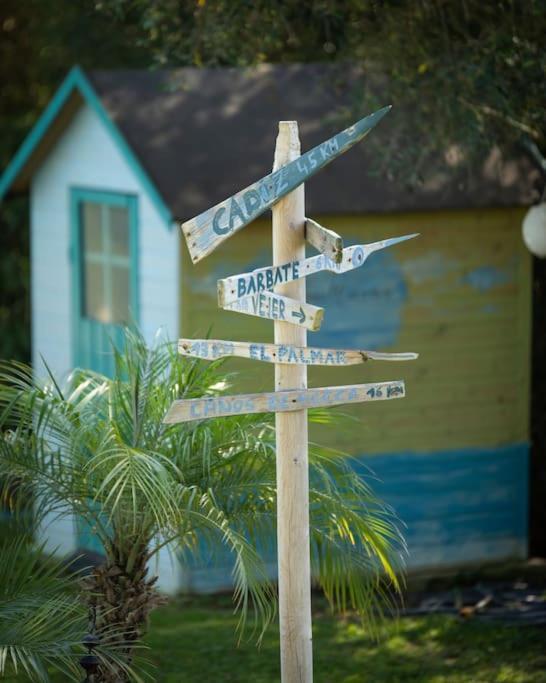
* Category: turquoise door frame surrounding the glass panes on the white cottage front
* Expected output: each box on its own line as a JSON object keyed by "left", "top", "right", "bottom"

{"left": 70, "top": 188, "right": 140, "bottom": 375}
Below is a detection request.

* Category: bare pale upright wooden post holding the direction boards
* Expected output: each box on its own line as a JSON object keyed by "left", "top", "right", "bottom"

{"left": 272, "top": 121, "right": 313, "bottom": 683}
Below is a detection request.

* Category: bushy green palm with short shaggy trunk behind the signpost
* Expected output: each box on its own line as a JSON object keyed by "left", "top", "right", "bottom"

{"left": 0, "top": 330, "right": 403, "bottom": 681}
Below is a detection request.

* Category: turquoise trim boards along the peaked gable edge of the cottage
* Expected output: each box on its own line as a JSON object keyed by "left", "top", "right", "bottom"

{"left": 0, "top": 66, "right": 173, "bottom": 228}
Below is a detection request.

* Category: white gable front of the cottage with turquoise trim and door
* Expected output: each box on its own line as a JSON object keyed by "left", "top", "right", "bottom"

{"left": 0, "top": 67, "right": 180, "bottom": 590}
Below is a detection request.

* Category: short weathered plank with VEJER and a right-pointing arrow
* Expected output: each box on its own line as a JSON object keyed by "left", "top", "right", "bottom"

{"left": 223, "top": 292, "right": 324, "bottom": 331}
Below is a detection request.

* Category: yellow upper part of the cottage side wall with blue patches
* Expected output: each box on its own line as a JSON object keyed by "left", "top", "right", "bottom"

{"left": 180, "top": 209, "right": 531, "bottom": 454}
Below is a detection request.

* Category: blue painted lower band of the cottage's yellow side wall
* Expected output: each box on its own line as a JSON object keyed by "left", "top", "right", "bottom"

{"left": 182, "top": 443, "right": 529, "bottom": 593}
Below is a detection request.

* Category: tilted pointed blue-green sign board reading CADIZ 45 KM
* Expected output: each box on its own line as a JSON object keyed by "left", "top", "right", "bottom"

{"left": 182, "top": 107, "right": 390, "bottom": 263}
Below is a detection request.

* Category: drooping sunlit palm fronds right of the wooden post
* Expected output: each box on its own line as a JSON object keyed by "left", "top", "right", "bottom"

{"left": 310, "top": 444, "right": 407, "bottom": 635}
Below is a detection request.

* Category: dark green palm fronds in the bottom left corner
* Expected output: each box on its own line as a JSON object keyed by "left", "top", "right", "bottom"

{"left": 0, "top": 530, "right": 142, "bottom": 682}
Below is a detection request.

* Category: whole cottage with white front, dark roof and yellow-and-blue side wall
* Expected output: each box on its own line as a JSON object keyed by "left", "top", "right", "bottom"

{"left": 0, "top": 65, "right": 537, "bottom": 590}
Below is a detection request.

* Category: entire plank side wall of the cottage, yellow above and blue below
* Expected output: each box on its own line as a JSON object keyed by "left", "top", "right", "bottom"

{"left": 181, "top": 204, "right": 531, "bottom": 591}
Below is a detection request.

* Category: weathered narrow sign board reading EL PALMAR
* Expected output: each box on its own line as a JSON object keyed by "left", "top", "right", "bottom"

{"left": 178, "top": 339, "right": 419, "bottom": 366}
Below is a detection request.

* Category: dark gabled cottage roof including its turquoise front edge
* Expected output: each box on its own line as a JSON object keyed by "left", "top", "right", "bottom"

{"left": 0, "top": 65, "right": 537, "bottom": 220}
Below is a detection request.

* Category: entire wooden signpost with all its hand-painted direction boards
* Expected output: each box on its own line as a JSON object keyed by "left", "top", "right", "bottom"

{"left": 164, "top": 107, "right": 417, "bottom": 683}
